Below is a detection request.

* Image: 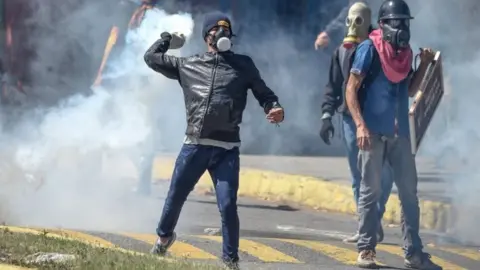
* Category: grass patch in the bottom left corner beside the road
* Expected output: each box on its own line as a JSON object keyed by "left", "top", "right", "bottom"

{"left": 0, "top": 229, "right": 221, "bottom": 270}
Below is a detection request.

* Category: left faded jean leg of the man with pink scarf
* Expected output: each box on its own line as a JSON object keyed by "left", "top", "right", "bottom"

{"left": 357, "top": 135, "right": 386, "bottom": 251}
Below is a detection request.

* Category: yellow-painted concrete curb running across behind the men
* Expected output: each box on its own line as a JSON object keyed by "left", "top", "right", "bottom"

{"left": 153, "top": 157, "right": 451, "bottom": 230}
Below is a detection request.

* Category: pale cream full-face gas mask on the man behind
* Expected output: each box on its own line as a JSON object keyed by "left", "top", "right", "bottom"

{"left": 343, "top": 2, "right": 372, "bottom": 49}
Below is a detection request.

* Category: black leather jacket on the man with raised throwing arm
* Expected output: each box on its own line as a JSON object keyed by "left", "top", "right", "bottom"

{"left": 144, "top": 39, "right": 280, "bottom": 142}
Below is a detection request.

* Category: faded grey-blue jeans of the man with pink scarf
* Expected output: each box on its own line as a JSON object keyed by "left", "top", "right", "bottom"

{"left": 357, "top": 135, "right": 423, "bottom": 256}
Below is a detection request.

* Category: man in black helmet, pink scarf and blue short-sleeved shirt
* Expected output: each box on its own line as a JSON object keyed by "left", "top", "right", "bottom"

{"left": 346, "top": 0, "right": 441, "bottom": 270}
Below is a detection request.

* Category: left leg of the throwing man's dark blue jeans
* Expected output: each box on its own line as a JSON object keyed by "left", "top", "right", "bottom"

{"left": 157, "top": 144, "right": 212, "bottom": 237}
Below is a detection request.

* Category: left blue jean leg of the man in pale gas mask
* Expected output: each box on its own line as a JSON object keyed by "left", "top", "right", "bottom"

{"left": 342, "top": 115, "right": 362, "bottom": 208}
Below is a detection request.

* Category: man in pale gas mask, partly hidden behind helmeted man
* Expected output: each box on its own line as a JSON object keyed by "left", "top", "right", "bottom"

{"left": 320, "top": 2, "right": 393, "bottom": 243}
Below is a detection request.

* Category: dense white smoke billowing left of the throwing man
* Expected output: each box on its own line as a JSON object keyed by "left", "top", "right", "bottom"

{"left": 0, "top": 5, "right": 194, "bottom": 230}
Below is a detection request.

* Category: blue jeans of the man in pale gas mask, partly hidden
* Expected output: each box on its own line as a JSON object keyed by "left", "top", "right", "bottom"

{"left": 342, "top": 115, "right": 393, "bottom": 220}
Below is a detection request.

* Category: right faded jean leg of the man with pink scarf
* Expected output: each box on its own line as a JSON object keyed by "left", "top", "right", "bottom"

{"left": 387, "top": 137, "right": 423, "bottom": 255}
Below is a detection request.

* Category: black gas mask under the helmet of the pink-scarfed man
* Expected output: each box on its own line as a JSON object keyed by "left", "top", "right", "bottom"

{"left": 380, "top": 19, "right": 410, "bottom": 50}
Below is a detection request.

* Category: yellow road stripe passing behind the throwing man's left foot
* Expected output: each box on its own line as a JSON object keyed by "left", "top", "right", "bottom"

{"left": 121, "top": 233, "right": 217, "bottom": 260}
